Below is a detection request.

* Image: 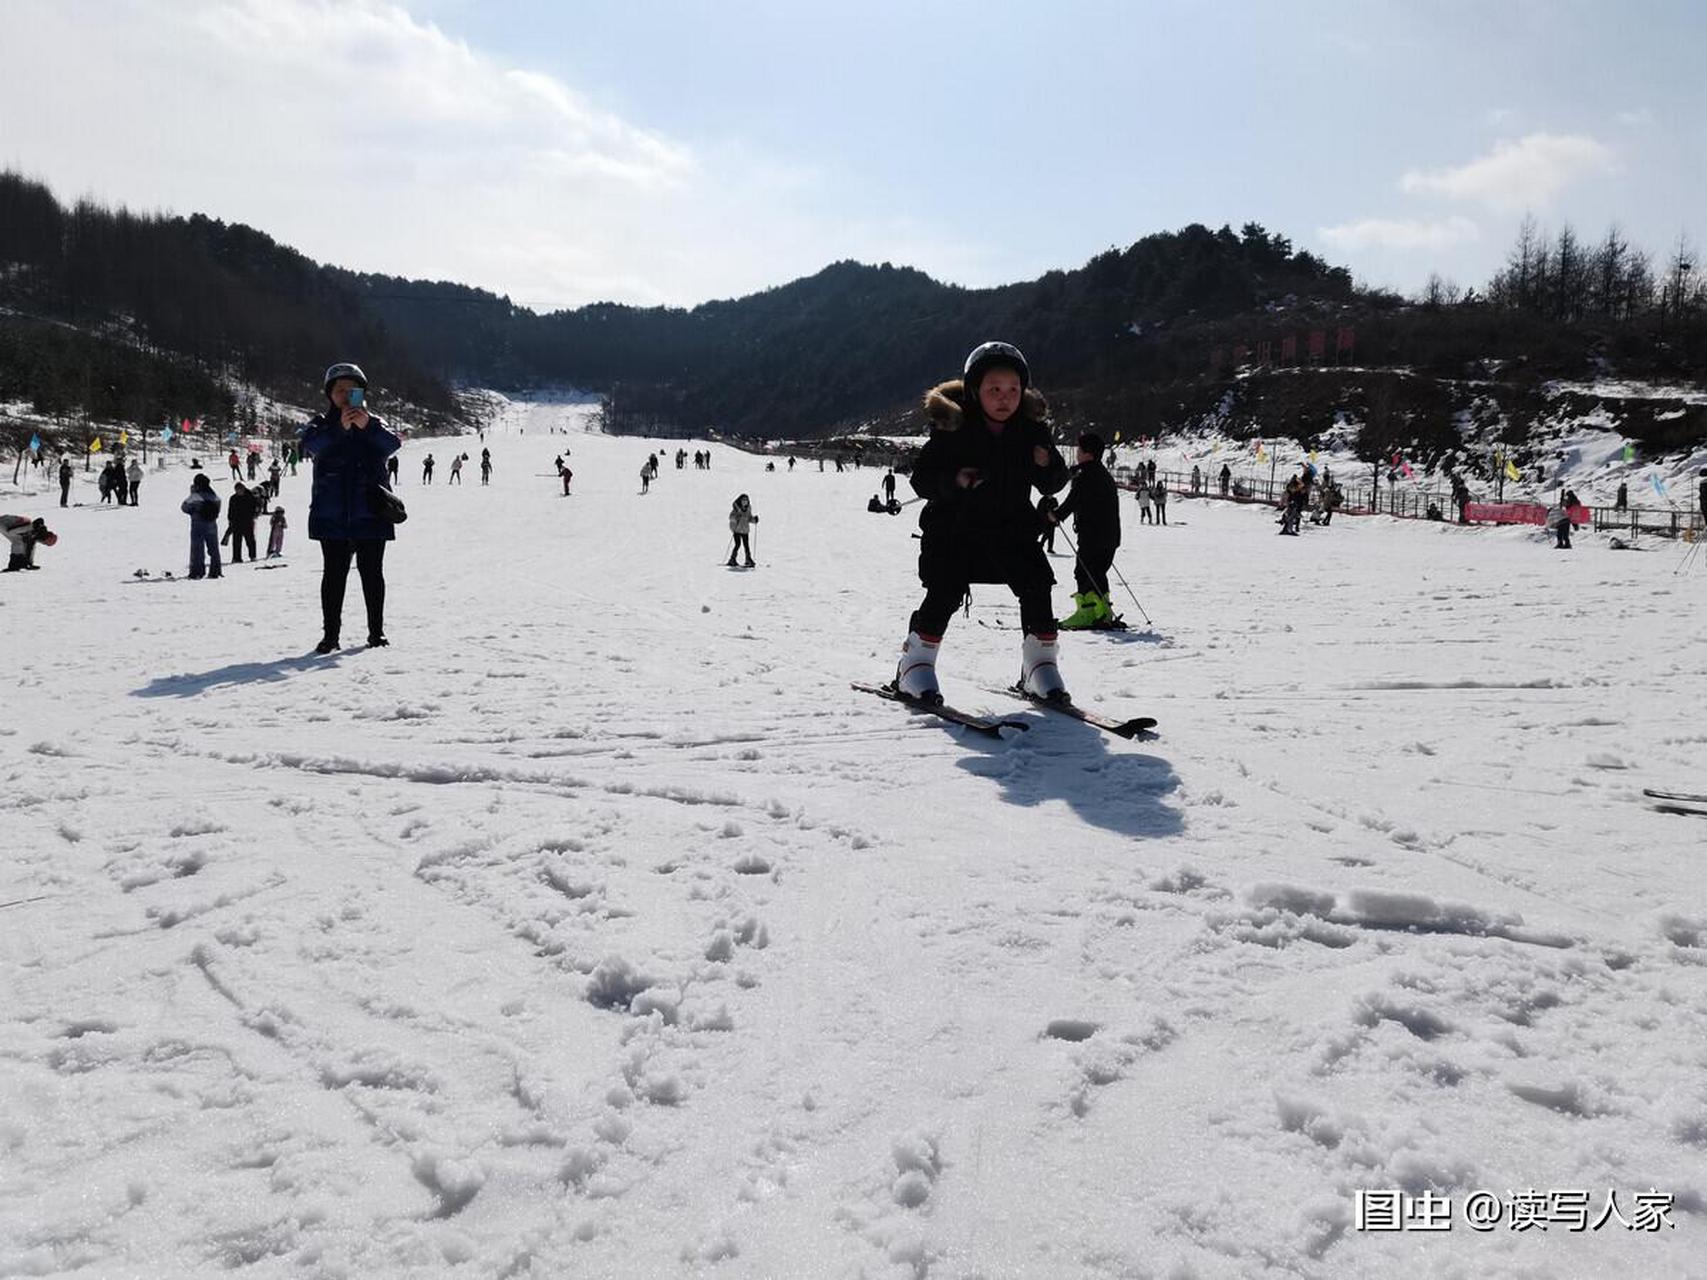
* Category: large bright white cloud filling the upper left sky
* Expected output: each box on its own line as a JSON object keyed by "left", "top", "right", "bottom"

{"left": 0, "top": 0, "right": 956, "bottom": 307}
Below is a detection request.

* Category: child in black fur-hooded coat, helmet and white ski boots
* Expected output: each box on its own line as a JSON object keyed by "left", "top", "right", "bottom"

{"left": 894, "top": 341, "right": 1067, "bottom": 703}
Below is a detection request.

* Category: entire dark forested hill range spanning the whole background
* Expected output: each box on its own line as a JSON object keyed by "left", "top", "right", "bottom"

{"left": 0, "top": 165, "right": 1707, "bottom": 457}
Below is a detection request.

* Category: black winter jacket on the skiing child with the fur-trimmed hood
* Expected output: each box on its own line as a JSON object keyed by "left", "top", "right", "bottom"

{"left": 912, "top": 379, "right": 1067, "bottom": 587}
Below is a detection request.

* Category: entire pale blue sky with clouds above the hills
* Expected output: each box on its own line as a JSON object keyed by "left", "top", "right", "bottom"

{"left": 0, "top": 0, "right": 1707, "bottom": 307}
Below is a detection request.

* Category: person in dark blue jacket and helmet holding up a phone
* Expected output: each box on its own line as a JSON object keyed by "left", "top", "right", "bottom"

{"left": 300, "top": 364, "right": 401, "bottom": 654}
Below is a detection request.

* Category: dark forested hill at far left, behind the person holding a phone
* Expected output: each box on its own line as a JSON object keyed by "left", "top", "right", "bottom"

{"left": 0, "top": 172, "right": 457, "bottom": 428}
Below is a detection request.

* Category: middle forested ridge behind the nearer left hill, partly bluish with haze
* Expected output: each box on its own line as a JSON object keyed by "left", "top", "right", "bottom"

{"left": 348, "top": 225, "right": 1357, "bottom": 437}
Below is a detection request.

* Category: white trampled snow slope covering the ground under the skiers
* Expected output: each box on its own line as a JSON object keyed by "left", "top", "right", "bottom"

{"left": 0, "top": 403, "right": 1707, "bottom": 1280}
